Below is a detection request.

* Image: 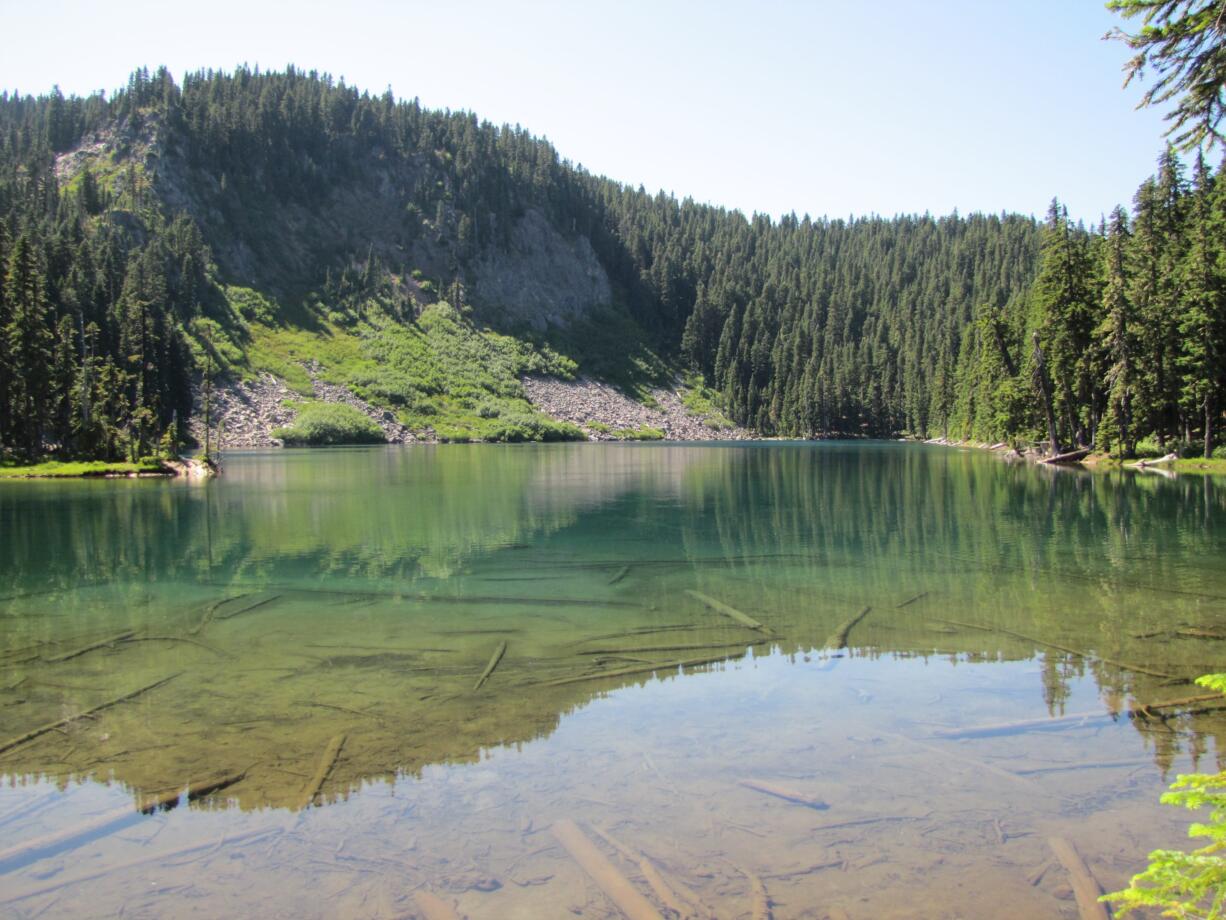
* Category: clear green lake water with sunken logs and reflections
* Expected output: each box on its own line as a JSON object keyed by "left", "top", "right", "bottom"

{"left": 0, "top": 443, "right": 1226, "bottom": 919}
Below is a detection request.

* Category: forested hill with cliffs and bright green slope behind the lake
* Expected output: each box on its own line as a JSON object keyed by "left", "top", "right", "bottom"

{"left": 0, "top": 69, "right": 1041, "bottom": 456}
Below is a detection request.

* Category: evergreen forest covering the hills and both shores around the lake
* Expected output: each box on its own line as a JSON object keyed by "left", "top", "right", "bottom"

{"left": 0, "top": 67, "right": 1226, "bottom": 460}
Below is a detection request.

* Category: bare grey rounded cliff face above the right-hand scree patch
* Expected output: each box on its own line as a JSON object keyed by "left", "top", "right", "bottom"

{"left": 473, "top": 209, "right": 613, "bottom": 329}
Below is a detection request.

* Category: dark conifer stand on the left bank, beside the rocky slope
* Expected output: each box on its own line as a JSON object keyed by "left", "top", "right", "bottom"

{"left": 0, "top": 75, "right": 201, "bottom": 460}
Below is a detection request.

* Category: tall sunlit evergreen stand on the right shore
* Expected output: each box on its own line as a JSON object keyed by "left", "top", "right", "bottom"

{"left": 958, "top": 150, "right": 1226, "bottom": 456}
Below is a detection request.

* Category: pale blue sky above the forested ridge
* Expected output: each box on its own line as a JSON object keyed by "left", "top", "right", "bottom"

{"left": 0, "top": 0, "right": 1186, "bottom": 221}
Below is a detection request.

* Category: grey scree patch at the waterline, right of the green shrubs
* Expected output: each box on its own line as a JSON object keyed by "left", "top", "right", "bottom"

{"left": 524, "top": 377, "right": 754, "bottom": 440}
